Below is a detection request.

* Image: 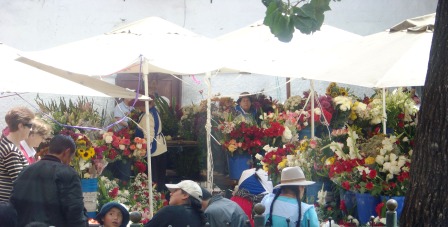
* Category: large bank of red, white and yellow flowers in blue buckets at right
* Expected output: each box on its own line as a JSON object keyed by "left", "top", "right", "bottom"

{"left": 208, "top": 83, "right": 417, "bottom": 224}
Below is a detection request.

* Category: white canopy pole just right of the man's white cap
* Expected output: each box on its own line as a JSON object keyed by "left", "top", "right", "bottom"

{"left": 205, "top": 72, "right": 213, "bottom": 191}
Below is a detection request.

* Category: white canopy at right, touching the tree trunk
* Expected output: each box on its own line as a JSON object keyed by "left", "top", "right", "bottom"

{"left": 296, "top": 14, "right": 435, "bottom": 88}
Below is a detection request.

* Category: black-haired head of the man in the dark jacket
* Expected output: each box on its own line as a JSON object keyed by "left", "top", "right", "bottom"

{"left": 48, "top": 135, "right": 76, "bottom": 165}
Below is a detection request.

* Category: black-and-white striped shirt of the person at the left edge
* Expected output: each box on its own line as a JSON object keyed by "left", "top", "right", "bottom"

{"left": 0, "top": 136, "right": 28, "bottom": 201}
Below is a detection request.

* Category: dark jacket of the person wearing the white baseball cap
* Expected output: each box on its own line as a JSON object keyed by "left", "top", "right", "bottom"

{"left": 145, "top": 205, "right": 202, "bottom": 227}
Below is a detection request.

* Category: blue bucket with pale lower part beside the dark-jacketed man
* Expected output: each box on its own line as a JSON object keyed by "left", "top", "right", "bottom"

{"left": 81, "top": 178, "right": 98, "bottom": 218}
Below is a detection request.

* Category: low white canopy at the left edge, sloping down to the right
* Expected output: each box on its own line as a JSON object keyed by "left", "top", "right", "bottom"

{"left": 0, "top": 43, "right": 141, "bottom": 98}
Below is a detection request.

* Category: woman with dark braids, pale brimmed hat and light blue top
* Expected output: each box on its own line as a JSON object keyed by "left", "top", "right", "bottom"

{"left": 261, "top": 167, "right": 319, "bottom": 227}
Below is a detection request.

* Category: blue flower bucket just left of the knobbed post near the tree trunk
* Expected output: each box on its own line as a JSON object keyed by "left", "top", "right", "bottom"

{"left": 356, "top": 193, "right": 381, "bottom": 225}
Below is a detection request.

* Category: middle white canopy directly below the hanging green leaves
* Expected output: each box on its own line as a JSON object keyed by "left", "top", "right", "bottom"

{"left": 217, "top": 20, "right": 361, "bottom": 75}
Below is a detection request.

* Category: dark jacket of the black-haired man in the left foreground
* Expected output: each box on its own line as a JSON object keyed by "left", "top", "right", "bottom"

{"left": 11, "top": 155, "right": 88, "bottom": 227}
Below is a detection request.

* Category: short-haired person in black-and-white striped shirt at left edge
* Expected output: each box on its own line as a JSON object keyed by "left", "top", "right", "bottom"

{"left": 0, "top": 107, "right": 34, "bottom": 201}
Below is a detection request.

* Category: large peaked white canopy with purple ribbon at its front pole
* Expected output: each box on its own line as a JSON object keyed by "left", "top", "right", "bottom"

{"left": 19, "top": 17, "right": 222, "bottom": 76}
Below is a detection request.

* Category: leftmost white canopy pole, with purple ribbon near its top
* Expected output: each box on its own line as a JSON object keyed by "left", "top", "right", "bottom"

{"left": 143, "top": 59, "right": 155, "bottom": 218}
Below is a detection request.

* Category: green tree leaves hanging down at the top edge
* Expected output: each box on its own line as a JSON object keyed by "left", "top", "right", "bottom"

{"left": 262, "top": 0, "right": 331, "bottom": 42}
